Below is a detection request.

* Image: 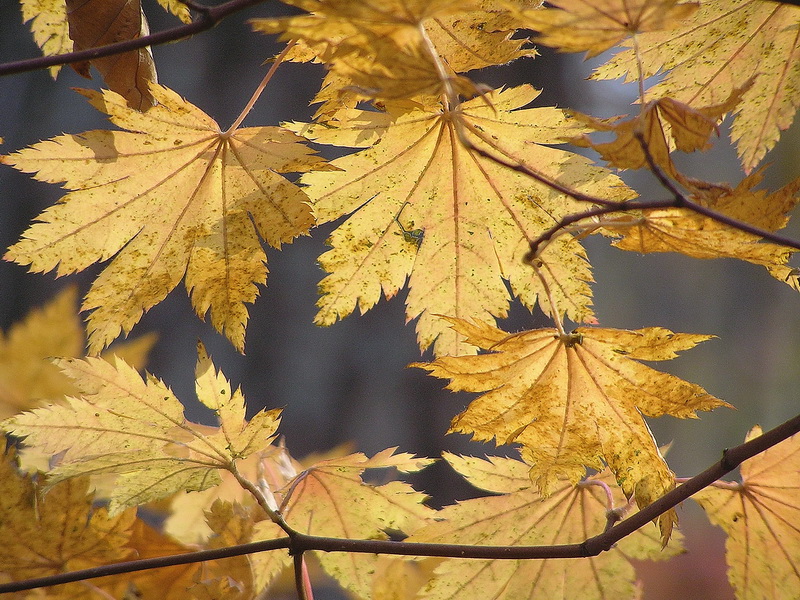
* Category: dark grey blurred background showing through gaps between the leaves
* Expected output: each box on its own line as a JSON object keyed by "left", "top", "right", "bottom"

{"left": 0, "top": 1, "right": 800, "bottom": 599}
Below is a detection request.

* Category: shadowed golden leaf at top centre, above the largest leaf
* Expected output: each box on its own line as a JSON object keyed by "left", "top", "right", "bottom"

{"left": 252, "top": 0, "right": 535, "bottom": 110}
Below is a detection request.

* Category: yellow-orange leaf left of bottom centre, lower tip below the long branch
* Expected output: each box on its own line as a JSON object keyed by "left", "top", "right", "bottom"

{"left": 281, "top": 448, "right": 435, "bottom": 597}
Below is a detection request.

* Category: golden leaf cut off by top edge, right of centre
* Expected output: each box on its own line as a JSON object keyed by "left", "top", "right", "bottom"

{"left": 519, "top": 0, "right": 698, "bottom": 58}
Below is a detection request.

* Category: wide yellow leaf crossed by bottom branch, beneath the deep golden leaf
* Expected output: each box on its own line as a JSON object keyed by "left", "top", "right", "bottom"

{"left": 409, "top": 454, "right": 681, "bottom": 600}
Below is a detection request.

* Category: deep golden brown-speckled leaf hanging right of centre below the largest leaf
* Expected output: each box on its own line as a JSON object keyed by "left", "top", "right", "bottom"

{"left": 412, "top": 318, "right": 728, "bottom": 539}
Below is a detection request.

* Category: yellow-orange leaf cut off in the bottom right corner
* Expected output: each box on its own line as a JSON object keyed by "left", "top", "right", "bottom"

{"left": 692, "top": 426, "right": 800, "bottom": 600}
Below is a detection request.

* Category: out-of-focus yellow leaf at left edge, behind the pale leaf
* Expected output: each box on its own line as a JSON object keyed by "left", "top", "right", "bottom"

{"left": 0, "top": 287, "right": 156, "bottom": 419}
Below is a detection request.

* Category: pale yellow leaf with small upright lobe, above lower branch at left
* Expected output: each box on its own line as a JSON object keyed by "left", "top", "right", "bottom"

{"left": 2, "top": 344, "right": 280, "bottom": 514}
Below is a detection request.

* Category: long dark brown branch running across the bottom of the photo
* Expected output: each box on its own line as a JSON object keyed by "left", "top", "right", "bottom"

{"left": 0, "top": 415, "right": 800, "bottom": 593}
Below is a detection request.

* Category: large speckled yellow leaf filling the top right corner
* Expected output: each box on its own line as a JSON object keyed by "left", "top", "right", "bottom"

{"left": 593, "top": 0, "right": 800, "bottom": 173}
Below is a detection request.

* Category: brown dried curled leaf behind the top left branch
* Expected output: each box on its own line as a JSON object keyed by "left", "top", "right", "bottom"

{"left": 66, "top": 0, "right": 156, "bottom": 110}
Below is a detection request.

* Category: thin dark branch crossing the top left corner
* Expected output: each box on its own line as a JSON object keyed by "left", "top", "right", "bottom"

{"left": 0, "top": 0, "right": 266, "bottom": 76}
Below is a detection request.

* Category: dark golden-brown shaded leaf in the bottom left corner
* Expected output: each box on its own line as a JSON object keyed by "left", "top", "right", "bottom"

{"left": 0, "top": 451, "right": 136, "bottom": 584}
